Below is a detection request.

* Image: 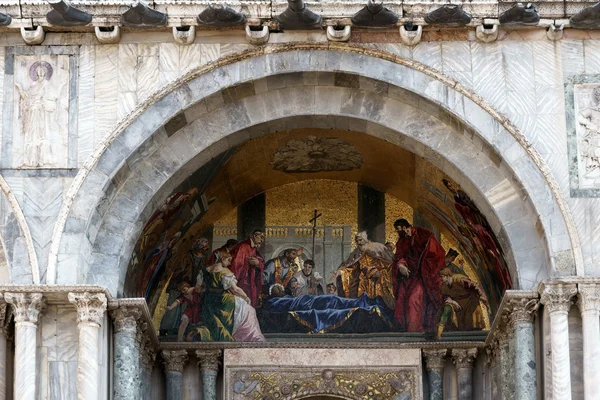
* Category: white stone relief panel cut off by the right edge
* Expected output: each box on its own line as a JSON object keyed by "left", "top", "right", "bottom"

{"left": 574, "top": 85, "right": 600, "bottom": 188}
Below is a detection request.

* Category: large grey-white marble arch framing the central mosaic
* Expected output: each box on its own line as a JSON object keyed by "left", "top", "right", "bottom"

{"left": 49, "top": 45, "right": 581, "bottom": 293}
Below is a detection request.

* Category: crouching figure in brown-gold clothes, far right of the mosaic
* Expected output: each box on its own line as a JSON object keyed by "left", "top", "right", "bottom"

{"left": 435, "top": 267, "right": 488, "bottom": 339}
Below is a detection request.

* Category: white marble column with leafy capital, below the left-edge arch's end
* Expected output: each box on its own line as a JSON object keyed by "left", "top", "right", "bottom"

{"left": 4, "top": 293, "right": 45, "bottom": 400}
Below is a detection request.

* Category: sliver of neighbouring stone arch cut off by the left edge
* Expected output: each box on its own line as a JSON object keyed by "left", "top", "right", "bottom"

{"left": 0, "top": 176, "right": 40, "bottom": 284}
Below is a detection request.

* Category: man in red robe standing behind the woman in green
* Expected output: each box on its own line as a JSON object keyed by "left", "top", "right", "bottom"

{"left": 229, "top": 229, "right": 265, "bottom": 308}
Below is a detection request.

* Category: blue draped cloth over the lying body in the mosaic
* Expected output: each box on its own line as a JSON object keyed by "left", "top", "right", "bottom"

{"left": 263, "top": 294, "right": 393, "bottom": 333}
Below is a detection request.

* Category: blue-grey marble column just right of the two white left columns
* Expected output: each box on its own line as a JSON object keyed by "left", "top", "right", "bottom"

{"left": 110, "top": 306, "right": 141, "bottom": 400}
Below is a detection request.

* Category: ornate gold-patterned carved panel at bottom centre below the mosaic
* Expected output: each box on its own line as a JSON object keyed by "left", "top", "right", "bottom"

{"left": 225, "top": 368, "right": 421, "bottom": 400}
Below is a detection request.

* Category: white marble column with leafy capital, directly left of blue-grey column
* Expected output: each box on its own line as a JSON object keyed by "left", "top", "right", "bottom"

{"left": 68, "top": 292, "right": 107, "bottom": 400}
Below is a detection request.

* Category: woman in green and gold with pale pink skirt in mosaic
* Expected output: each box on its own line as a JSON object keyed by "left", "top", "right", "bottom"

{"left": 188, "top": 251, "right": 265, "bottom": 342}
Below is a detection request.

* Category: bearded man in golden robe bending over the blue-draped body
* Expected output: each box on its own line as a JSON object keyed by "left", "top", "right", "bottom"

{"left": 335, "top": 232, "right": 396, "bottom": 310}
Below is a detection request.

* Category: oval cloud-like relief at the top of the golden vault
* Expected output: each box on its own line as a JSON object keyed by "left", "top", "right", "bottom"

{"left": 271, "top": 136, "right": 363, "bottom": 172}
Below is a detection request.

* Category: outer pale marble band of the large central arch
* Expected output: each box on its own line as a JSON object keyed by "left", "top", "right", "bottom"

{"left": 50, "top": 45, "right": 579, "bottom": 294}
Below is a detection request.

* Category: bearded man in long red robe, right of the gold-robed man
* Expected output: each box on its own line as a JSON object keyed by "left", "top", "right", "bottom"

{"left": 392, "top": 219, "right": 446, "bottom": 332}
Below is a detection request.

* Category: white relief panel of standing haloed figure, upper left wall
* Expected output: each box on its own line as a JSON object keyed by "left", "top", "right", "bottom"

{"left": 13, "top": 55, "right": 69, "bottom": 168}
